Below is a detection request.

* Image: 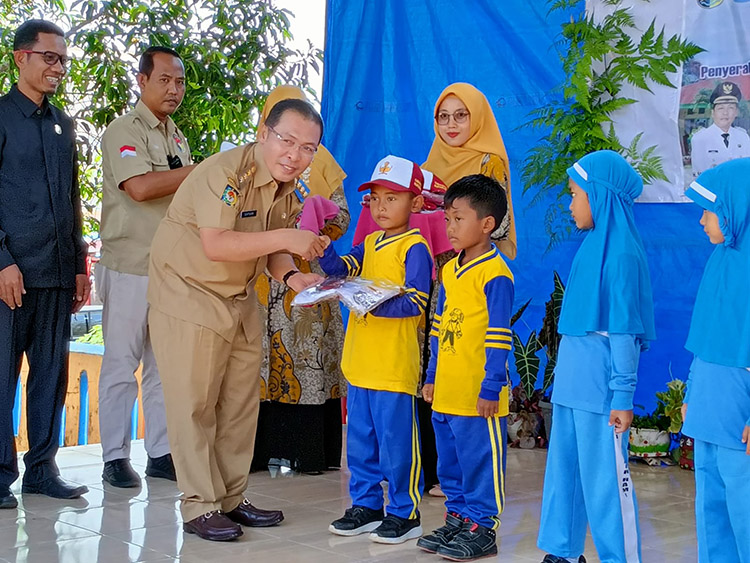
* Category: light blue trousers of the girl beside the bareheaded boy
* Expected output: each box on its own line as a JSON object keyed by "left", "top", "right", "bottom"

{"left": 537, "top": 405, "right": 641, "bottom": 563}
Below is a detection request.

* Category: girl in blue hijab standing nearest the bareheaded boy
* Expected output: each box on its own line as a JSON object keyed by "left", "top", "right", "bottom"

{"left": 537, "top": 151, "right": 655, "bottom": 563}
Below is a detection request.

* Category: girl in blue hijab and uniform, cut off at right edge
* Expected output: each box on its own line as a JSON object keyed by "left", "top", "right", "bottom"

{"left": 682, "top": 158, "right": 750, "bottom": 563}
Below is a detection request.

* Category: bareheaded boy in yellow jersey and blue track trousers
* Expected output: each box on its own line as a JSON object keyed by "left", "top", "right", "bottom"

{"left": 417, "top": 174, "right": 514, "bottom": 561}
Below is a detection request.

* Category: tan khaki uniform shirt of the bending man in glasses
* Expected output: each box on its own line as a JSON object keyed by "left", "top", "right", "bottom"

{"left": 148, "top": 144, "right": 301, "bottom": 342}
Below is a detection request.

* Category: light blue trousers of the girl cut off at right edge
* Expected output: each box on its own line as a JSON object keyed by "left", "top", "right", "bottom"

{"left": 694, "top": 440, "right": 750, "bottom": 563}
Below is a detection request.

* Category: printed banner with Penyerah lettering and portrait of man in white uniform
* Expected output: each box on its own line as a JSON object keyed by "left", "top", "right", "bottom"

{"left": 679, "top": 0, "right": 750, "bottom": 186}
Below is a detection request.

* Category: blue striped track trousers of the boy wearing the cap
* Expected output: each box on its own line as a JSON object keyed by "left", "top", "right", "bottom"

{"left": 346, "top": 385, "right": 424, "bottom": 519}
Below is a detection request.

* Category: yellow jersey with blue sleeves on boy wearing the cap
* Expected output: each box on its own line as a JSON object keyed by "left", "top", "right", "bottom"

{"left": 320, "top": 229, "right": 432, "bottom": 395}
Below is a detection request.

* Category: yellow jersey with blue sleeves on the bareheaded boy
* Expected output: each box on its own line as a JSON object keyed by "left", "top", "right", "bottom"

{"left": 427, "top": 245, "right": 513, "bottom": 416}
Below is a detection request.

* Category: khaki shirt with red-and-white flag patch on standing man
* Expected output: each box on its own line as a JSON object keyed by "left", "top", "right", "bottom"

{"left": 101, "top": 100, "right": 191, "bottom": 276}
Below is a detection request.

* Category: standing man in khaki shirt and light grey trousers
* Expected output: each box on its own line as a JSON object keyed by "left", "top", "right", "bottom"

{"left": 96, "top": 47, "right": 194, "bottom": 487}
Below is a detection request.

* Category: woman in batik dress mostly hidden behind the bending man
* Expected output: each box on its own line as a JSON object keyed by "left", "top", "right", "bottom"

{"left": 253, "top": 86, "right": 349, "bottom": 473}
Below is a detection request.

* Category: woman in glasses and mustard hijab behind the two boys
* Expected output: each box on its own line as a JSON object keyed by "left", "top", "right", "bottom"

{"left": 419, "top": 82, "right": 516, "bottom": 496}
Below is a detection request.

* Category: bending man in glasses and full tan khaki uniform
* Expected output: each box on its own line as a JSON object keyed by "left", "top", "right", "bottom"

{"left": 148, "top": 100, "right": 330, "bottom": 541}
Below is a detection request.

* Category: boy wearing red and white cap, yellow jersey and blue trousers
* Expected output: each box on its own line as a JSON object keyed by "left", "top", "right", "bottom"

{"left": 320, "top": 155, "right": 432, "bottom": 543}
